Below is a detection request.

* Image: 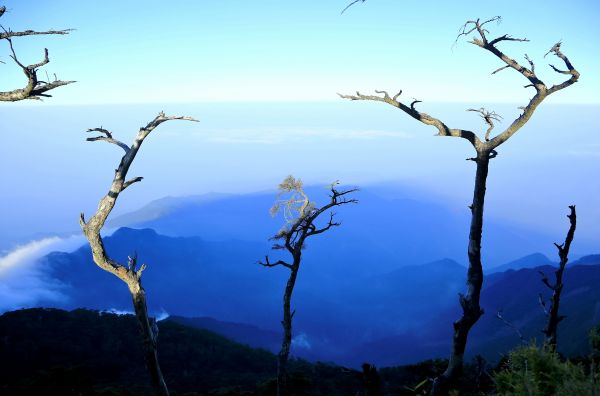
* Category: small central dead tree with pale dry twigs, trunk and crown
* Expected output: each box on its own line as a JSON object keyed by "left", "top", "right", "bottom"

{"left": 259, "top": 176, "right": 358, "bottom": 396}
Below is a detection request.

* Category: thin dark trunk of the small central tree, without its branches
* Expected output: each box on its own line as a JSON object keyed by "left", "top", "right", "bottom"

{"left": 277, "top": 255, "right": 300, "bottom": 396}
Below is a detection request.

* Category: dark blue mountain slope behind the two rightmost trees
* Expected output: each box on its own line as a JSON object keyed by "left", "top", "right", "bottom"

{"left": 345, "top": 265, "right": 600, "bottom": 365}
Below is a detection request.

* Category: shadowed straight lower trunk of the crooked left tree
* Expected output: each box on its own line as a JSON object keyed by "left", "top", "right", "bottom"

{"left": 130, "top": 282, "right": 169, "bottom": 396}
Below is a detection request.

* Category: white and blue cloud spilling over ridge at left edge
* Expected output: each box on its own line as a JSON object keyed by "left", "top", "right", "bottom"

{"left": 0, "top": 236, "right": 83, "bottom": 312}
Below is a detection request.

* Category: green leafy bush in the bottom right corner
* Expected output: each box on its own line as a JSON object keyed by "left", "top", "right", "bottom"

{"left": 495, "top": 344, "right": 600, "bottom": 396}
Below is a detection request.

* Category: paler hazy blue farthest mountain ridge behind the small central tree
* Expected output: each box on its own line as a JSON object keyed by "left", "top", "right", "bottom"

{"left": 109, "top": 187, "right": 572, "bottom": 270}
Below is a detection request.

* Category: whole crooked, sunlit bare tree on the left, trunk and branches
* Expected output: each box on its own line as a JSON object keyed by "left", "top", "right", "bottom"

{"left": 79, "top": 112, "right": 196, "bottom": 396}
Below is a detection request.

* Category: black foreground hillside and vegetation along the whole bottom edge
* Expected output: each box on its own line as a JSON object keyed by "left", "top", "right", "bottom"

{"left": 0, "top": 308, "right": 598, "bottom": 396}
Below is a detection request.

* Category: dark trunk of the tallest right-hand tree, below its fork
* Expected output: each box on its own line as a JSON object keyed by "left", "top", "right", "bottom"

{"left": 431, "top": 151, "right": 490, "bottom": 395}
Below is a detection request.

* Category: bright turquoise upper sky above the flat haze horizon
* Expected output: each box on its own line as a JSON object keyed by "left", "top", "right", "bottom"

{"left": 1, "top": 0, "right": 600, "bottom": 105}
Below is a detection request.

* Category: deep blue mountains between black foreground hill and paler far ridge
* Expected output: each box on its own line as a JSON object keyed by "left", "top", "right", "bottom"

{"left": 37, "top": 227, "right": 600, "bottom": 366}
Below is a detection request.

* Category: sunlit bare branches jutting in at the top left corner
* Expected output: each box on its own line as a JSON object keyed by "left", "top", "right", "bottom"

{"left": 0, "top": 6, "right": 75, "bottom": 102}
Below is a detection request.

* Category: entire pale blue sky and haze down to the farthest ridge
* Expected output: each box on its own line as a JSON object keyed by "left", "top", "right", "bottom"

{"left": 0, "top": 0, "right": 600, "bottom": 254}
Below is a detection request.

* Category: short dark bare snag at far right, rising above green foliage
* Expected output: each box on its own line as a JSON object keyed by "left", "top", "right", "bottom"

{"left": 540, "top": 205, "right": 577, "bottom": 349}
